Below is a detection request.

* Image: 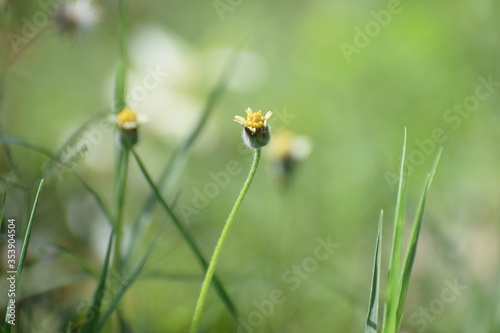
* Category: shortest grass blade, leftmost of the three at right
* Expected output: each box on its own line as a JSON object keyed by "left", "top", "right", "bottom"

{"left": 365, "top": 210, "right": 384, "bottom": 333}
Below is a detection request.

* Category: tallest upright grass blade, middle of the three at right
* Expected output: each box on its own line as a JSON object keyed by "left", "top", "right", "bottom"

{"left": 382, "top": 128, "right": 408, "bottom": 333}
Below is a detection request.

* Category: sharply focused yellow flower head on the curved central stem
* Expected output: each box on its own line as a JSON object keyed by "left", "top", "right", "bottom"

{"left": 234, "top": 108, "right": 273, "bottom": 148}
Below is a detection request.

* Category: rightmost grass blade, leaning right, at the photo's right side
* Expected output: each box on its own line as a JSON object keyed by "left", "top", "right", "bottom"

{"left": 396, "top": 149, "right": 442, "bottom": 331}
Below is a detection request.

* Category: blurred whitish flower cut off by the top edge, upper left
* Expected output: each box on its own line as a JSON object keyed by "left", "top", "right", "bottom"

{"left": 54, "top": 0, "right": 101, "bottom": 34}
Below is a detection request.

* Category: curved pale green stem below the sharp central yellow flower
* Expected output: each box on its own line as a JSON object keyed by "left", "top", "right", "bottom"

{"left": 190, "top": 148, "right": 262, "bottom": 333}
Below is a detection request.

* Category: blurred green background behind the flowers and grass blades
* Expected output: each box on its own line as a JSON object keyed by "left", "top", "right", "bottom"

{"left": 0, "top": 0, "right": 500, "bottom": 333}
